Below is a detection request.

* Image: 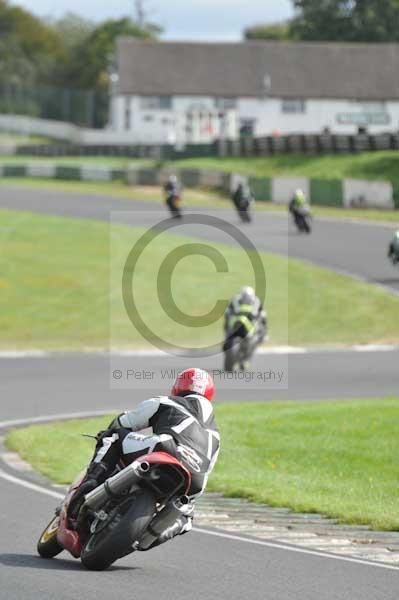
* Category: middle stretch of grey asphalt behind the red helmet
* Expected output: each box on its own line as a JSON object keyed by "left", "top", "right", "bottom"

{"left": 0, "top": 350, "right": 399, "bottom": 421}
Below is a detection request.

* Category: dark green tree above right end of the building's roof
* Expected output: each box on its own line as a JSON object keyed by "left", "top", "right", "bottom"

{"left": 291, "top": 0, "right": 399, "bottom": 42}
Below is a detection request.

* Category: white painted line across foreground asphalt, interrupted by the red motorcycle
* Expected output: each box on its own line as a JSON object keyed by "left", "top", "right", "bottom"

{"left": 0, "top": 469, "right": 399, "bottom": 571}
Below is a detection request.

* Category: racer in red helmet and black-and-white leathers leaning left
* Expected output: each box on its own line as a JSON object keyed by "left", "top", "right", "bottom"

{"left": 68, "top": 369, "right": 220, "bottom": 550}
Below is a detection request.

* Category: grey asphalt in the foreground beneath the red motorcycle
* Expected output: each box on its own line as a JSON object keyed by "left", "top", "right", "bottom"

{"left": 0, "top": 472, "right": 398, "bottom": 600}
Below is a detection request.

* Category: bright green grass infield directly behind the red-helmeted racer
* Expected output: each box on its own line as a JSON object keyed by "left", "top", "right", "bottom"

{"left": 6, "top": 398, "right": 399, "bottom": 530}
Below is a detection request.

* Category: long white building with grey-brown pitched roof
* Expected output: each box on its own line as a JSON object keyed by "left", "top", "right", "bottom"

{"left": 110, "top": 38, "right": 399, "bottom": 145}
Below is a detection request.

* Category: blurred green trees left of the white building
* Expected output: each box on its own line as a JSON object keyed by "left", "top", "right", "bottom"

{"left": 0, "top": 0, "right": 160, "bottom": 127}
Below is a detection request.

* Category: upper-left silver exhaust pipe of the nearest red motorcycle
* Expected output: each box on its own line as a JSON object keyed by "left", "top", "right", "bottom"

{"left": 84, "top": 461, "right": 151, "bottom": 510}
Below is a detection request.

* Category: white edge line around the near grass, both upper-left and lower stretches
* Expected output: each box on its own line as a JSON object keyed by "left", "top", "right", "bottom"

{"left": 0, "top": 408, "right": 399, "bottom": 571}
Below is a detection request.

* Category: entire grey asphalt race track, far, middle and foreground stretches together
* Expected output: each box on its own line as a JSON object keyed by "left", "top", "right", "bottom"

{"left": 0, "top": 187, "right": 399, "bottom": 600}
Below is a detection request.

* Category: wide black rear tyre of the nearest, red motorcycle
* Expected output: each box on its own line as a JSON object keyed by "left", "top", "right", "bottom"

{"left": 81, "top": 490, "right": 156, "bottom": 571}
